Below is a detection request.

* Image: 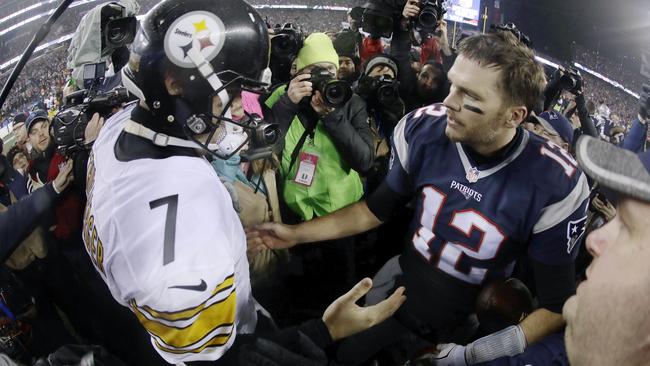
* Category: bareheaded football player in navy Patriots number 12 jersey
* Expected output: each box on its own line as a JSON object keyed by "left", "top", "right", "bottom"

{"left": 247, "top": 32, "right": 589, "bottom": 364}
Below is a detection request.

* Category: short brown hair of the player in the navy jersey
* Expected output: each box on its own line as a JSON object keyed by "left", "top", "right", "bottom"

{"left": 458, "top": 32, "right": 546, "bottom": 113}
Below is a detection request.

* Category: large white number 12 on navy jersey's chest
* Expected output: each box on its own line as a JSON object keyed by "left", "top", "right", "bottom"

{"left": 413, "top": 186, "right": 506, "bottom": 285}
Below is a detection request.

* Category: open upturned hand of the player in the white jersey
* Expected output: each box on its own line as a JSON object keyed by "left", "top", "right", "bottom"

{"left": 323, "top": 278, "right": 406, "bottom": 341}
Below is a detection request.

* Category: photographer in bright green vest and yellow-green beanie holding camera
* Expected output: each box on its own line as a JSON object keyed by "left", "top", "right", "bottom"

{"left": 266, "top": 33, "right": 374, "bottom": 321}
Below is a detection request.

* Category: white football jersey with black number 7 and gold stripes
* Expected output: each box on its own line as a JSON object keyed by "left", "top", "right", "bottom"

{"left": 83, "top": 108, "right": 257, "bottom": 363}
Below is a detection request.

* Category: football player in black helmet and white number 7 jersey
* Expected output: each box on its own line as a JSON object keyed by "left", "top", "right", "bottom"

{"left": 83, "top": 0, "right": 404, "bottom": 364}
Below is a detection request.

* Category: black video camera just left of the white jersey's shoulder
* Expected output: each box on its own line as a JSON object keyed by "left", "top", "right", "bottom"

{"left": 52, "top": 63, "right": 133, "bottom": 156}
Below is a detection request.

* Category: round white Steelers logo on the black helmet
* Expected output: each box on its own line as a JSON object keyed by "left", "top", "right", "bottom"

{"left": 164, "top": 11, "right": 226, "bottom": 68}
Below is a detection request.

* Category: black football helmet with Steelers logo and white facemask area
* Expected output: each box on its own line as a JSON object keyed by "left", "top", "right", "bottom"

{"left": 122, "top": 0, "right": 273, "bottom": 158}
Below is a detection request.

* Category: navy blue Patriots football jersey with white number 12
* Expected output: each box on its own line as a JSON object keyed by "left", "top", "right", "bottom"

{"left": 386, "top": 104, "right": 589, "bottom": 285}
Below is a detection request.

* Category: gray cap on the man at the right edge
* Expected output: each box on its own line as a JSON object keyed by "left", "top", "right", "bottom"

{"left": 576, "top": 136, "right": 650, "bottom": 202}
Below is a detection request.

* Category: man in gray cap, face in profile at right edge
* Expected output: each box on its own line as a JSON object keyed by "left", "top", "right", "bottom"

{"left": 563, "top": 98, "right": 650, "bottom": 366}
